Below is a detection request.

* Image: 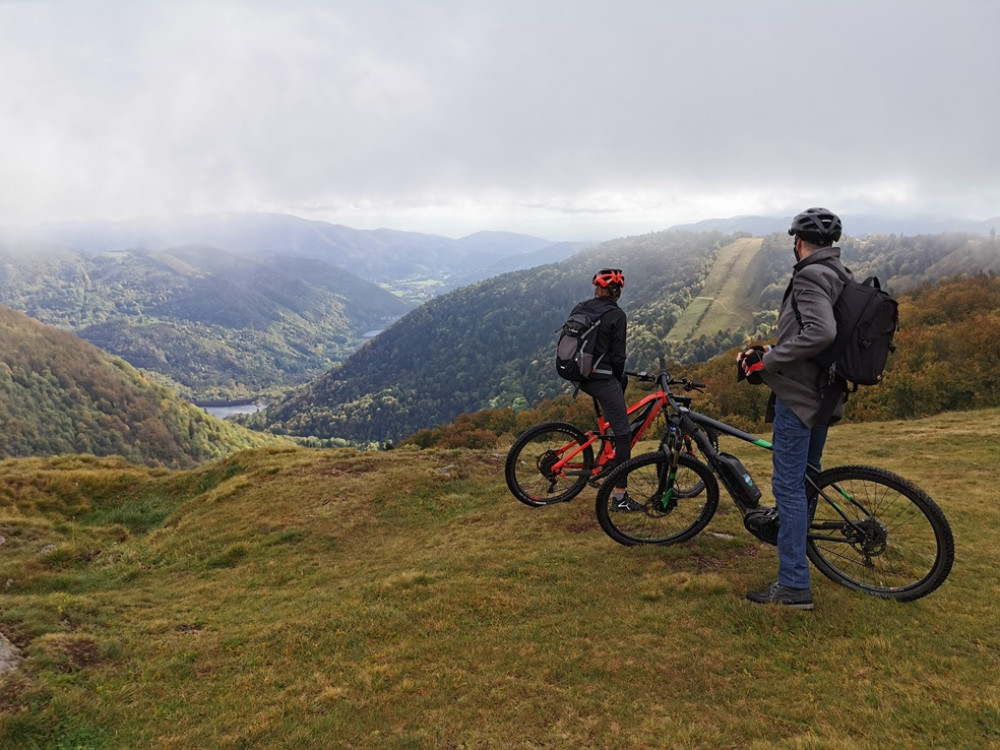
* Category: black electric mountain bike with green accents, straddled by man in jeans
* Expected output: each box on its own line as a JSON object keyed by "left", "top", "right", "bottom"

{"left": 597, "top": 369, "right": 955, "bottom": 601}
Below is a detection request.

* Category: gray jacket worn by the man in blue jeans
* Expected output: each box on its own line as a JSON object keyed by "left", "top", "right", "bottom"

{"left": 761, "top": 247, "right": 850, "bottom": 427}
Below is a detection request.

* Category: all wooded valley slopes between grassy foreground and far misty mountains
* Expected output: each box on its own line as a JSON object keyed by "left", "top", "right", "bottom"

{"left": 0, "top": 220, "right": 1000, "bottom": 465}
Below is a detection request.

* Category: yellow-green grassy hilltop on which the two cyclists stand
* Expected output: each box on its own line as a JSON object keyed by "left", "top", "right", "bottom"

{"left": 0, "top": 410, "right": 1000, "bottom": 750}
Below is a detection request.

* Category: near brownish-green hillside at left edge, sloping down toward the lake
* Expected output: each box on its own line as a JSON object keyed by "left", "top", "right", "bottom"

{"left": 0, "top": 307, "right": 277, "bottom": 468}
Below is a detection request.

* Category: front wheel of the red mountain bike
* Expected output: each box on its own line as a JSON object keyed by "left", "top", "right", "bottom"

{"left": 504, "top": 422, "right": 594, "bottom": 508}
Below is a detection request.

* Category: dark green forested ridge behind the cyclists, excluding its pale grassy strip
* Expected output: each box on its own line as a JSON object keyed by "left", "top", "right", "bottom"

{"left": 260, "top": 232, "right": 1000, "bottom": 442}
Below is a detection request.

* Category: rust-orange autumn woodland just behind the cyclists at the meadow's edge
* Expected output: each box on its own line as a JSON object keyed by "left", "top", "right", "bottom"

{"left": 407, "top": 273, "right": 1000, "bottom": 448}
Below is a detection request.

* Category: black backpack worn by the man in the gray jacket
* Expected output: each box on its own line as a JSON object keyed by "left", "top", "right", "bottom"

{"left": 792, "top": 263, "right": 899, "bottom": 390}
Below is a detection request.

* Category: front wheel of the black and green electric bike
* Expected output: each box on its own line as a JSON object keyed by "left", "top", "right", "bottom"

{"left": 596, "top": 451, "right": 719, "bottom": 546}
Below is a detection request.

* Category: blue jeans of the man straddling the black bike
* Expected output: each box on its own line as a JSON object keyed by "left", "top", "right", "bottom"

{"left": 771, "top": 399, "right": 830, "bottom": 589}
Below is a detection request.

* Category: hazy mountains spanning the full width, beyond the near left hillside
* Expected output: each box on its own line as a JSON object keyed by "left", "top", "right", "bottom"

{"left": 0, "top": 214, "right": 1000, "bottom": 452}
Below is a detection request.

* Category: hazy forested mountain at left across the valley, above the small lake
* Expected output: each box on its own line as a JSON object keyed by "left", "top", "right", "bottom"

{"left": 0, "top": 247, "right": 411, "bottom": 400}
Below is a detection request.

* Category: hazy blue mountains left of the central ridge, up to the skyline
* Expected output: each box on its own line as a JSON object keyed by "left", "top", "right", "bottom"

{"left": 0, "top": 214, "right": 579, "bottom": 401}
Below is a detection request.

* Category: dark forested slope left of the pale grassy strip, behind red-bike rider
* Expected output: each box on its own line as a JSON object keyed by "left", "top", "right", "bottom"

{"left": 251, "top": 232, "right": 756, "bottom": 441}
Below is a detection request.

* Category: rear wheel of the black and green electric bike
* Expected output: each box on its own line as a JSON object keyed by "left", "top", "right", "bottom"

{"left": 806, "top": 466, "right": 955, "bottom": 601}
